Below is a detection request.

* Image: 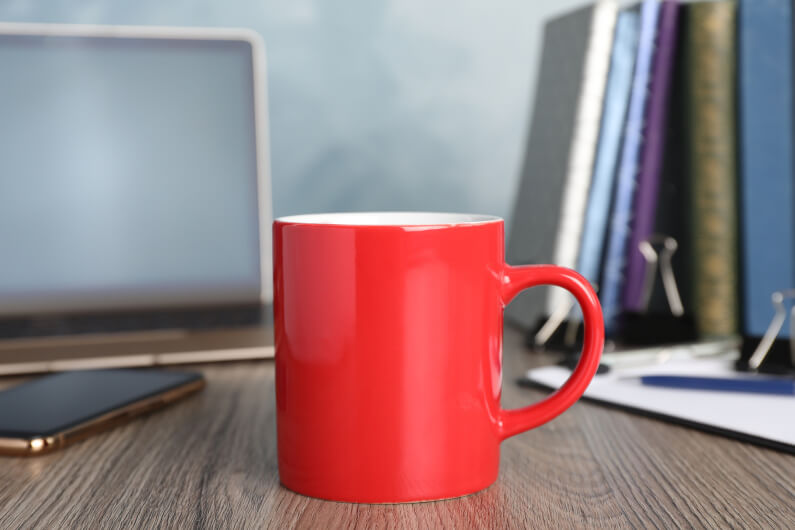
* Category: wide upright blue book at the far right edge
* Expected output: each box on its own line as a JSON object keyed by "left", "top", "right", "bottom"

{"left": 737, "top": 0, "right": 795, "bottom": 338}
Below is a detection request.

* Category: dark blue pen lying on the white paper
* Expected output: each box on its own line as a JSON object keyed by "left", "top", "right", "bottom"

{"left": 639, "top": 375, "right": 795, "bottom": 396}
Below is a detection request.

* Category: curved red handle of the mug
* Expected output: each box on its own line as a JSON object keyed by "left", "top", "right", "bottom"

{"left": 497, "top": 265, "right": 605, "bottom": 440}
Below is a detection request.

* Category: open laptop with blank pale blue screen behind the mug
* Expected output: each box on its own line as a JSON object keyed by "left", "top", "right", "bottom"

{"left": 0, "top": 24, "right": 273, "bottom": 374}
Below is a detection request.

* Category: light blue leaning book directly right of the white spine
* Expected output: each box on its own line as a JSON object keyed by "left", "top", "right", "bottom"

{"left": 577, "top": 7, "right": 640, "bottom": 292}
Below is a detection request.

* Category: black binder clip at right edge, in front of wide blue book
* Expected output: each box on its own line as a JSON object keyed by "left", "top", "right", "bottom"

{"left": 737, "top": 289, "right": 795, "bottom": 375}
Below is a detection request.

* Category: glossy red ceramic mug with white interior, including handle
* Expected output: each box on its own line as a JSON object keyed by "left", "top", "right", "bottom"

{"left": 273, "top": 212, "right": 604, "bottom": 503}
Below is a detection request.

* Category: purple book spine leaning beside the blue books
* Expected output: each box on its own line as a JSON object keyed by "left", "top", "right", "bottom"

{"left": 623, "top": 1, "right": 679, "bottom": 311}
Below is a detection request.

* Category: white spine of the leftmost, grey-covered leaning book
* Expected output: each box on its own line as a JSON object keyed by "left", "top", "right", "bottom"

{"left": 547, "top": 0, "right": 618, "bottom": 315}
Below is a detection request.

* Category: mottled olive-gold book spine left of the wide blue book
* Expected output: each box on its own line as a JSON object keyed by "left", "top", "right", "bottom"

{"left": 687, "top": 2, "right": 739, "bottom": 338}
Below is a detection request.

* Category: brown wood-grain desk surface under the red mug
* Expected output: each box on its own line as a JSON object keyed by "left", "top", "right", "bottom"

{"left": 0, "top": 330, "right": 795, "bottom": 529}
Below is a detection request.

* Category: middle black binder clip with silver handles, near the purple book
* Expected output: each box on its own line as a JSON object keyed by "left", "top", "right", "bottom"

{"left": 617, "top": 234, "right": 698, "bottom": 346}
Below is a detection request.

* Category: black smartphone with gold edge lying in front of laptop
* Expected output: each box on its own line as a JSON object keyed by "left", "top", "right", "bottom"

{"left": 0, "top": 369, "right": 204, "bottom": 455}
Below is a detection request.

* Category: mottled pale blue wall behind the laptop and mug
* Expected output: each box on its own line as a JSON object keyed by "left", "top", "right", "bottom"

{"left": 0, "top": 0, "right": 583, "bottom": 217}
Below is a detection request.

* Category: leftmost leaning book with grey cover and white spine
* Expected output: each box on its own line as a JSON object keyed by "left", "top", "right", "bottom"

{"left": 506, "top": 0, "right": 618, "bottom": 327}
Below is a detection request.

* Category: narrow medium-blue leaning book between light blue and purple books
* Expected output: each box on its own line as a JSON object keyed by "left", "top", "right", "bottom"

{"left": 599, "top": 0, "right": 660, "bottom": 336}
